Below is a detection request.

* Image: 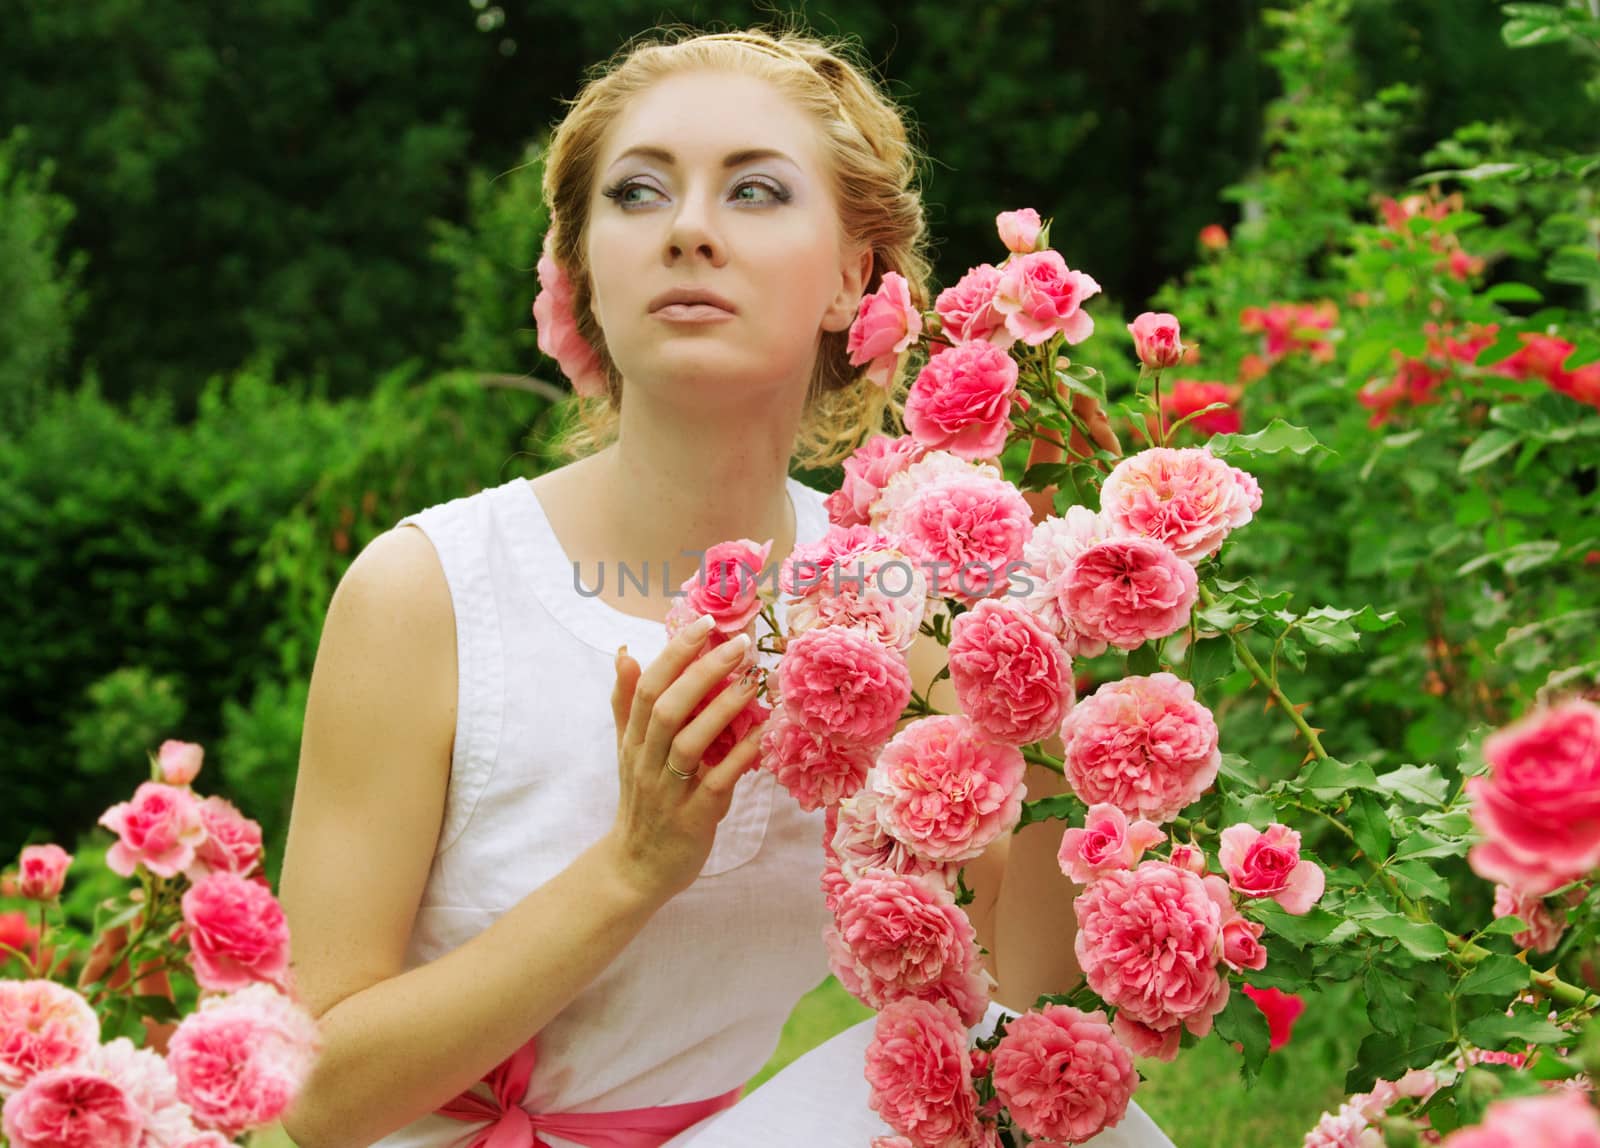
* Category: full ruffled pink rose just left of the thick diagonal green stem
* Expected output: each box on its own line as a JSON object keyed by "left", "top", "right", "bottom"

{"left": 1061, "top": 672, "right": 1222, "bottom": 823}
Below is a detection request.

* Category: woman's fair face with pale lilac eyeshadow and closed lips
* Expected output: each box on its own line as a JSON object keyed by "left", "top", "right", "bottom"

{"left": 587, "top": 72, "right": 872, "bottom": 401}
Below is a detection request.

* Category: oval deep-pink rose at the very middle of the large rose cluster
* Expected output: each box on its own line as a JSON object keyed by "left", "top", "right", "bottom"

{"left": 949, "top": 598, "right": 1072, "bottom": 745}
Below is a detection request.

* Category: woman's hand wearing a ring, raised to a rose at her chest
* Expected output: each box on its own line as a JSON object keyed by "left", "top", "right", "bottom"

{"left": 608, "top": 627, "right": 765, "bottom": 902}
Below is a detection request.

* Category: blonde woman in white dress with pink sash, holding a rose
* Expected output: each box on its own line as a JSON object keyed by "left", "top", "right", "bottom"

{"left": 282, "top": 32, "right": 1166, "bottom": 1148}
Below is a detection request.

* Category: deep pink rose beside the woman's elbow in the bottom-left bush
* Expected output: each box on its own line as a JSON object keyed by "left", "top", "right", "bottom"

{"left": 182, "top": 871, "right": 290, "bottom": 993}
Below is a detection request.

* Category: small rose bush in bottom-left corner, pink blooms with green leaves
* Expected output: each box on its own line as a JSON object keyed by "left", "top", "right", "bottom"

{"left": 0, "top": 740, "right": 320, "bottom": 1148}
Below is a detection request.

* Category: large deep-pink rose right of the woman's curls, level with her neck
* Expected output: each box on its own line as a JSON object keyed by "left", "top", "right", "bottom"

{"left": 906, "top": 342, "right": 1016, "bottom": 459}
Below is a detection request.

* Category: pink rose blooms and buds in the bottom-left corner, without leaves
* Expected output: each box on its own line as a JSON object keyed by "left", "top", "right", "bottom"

{"left": 0, "top": 740, "right": 320, "bottom": 1148}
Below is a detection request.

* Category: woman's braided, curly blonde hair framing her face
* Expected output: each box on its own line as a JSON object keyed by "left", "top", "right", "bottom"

{"left": 544, "top": 19, "right": 931, "bottom": 467}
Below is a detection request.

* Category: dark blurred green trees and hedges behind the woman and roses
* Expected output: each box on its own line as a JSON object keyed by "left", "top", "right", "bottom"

{"left": 0, "top": 0, "right": 1600, "bottom": 1146}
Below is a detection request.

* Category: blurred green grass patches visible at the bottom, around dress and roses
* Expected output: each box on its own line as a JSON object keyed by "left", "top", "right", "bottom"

{"left": 251, "top": 977, "right": 1360, "bottom": 1148}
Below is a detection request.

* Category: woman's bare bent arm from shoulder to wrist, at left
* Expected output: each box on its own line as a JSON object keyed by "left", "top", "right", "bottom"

{"left": 280, "top": 528, "right": 661, "bottom": 1148}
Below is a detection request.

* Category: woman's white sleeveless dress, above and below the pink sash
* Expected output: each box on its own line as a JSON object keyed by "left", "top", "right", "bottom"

{"left": 378, "top": 478, "right": 1171, "bottom": 1148}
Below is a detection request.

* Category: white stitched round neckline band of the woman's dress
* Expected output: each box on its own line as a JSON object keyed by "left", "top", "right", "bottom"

{"left": 502, "top": 475, "right": 827, "bottom": 665}
